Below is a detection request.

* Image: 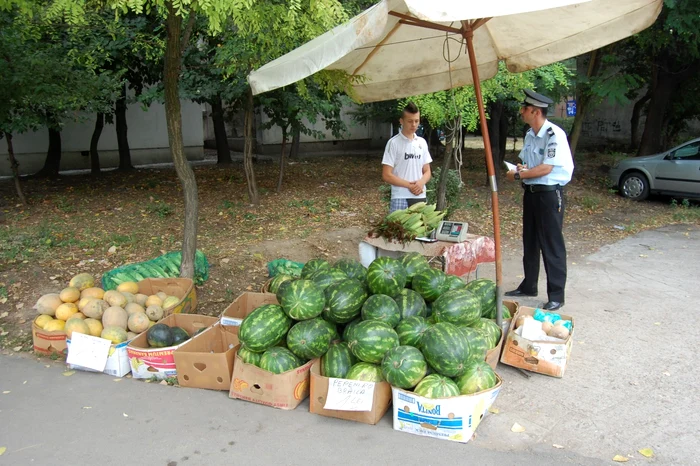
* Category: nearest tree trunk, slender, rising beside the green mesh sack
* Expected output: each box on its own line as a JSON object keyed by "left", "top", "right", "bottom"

{"left": 163, "top": 5, "right": 199, "bottom": 278}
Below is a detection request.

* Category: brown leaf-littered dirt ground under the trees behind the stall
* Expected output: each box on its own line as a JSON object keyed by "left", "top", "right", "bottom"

{"left": 0, "top": 149, "right": 700, "bottom": 352}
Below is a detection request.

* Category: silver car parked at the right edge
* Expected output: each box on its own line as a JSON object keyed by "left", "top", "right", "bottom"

{"left": 609, "top": 138, "right": 700, "bottom": 201}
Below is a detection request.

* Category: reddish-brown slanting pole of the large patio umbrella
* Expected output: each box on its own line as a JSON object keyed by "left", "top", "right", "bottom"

{"left": 462, "top": 27, "right": 503, "bottom": 329}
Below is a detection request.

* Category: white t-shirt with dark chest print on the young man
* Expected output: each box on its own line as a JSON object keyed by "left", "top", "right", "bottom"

{"left": 382, "top": 132, "right": 433, "bottom": 199}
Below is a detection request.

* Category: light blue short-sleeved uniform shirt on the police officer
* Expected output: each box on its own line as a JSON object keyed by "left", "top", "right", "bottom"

{"left": 520, "top": 120, "right": 574, "bottom": 186}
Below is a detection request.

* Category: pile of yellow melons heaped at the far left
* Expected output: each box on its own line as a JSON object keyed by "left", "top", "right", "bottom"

{"left": 34, "top": 273, "right": 180, "bottom": 344}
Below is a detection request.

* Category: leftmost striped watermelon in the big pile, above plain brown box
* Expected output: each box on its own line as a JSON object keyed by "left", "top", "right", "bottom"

{"left": 238, "top": 304, "right": 292, "bottom": 353}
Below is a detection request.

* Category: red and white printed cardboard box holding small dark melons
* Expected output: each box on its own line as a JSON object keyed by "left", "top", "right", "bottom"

{"left": 126, "top": 314, "right": 218, "bottom": 380}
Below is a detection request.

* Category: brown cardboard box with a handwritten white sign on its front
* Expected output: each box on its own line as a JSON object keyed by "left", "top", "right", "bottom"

{"left": 309, "top": 362, "right": 391, "bottom": 425}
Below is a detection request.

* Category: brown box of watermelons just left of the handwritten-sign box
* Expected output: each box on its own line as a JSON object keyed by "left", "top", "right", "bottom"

{"left": 229, "top": 347, "right": 315, "bottom": 409}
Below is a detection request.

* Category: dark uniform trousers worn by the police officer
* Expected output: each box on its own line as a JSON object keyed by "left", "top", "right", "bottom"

{"left": 518, "top": 185, "right": 566, "bottom": 303}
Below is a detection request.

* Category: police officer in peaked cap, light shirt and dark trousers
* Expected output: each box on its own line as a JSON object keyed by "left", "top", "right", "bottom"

{"left": 505, "top": 90, "right": 574, "bottom": 311}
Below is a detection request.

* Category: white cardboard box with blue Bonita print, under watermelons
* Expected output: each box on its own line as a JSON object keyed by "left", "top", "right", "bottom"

{"left": 391, "top": 376, "right": 502, "bottom": 443}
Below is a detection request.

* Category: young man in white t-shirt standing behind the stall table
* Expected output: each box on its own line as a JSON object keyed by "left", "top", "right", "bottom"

{"left": 382, "top": 102, "right": 433, "bottom": 212}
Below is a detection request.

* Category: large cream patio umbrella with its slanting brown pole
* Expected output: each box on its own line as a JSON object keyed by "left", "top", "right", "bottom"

{"left": 248, "top": 0, "right": 663, "bottom": 325}
